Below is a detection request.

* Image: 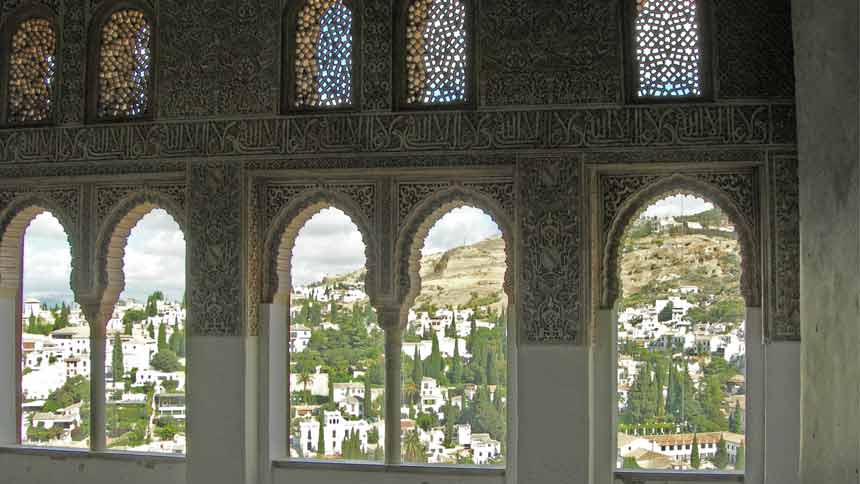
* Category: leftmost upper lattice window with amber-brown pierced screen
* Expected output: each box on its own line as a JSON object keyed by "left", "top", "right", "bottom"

{"left": 9, "top": 18, "right": 57, "bottom": 123}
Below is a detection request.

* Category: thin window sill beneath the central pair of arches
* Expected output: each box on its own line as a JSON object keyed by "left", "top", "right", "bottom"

{"left": 272, "top": 459, "right": 505, "bottom": 476}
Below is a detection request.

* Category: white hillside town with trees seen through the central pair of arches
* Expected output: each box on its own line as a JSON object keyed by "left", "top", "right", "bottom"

{"left": 290, "top": 246, "right": 507, "bottom": 465}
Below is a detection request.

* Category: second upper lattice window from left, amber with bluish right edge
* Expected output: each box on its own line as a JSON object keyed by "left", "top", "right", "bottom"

{"left": 89, "top": 5, "right": 156, "bottom": 120}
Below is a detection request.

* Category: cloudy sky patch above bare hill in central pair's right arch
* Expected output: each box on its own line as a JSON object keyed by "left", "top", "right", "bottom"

{"left": 421, "top": 206, "right": 501, "bottom": 254}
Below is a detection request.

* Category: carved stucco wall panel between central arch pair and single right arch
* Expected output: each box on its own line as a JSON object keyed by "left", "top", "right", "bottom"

{"left": 518, "top": 158, "right": 585, "bottom": 344}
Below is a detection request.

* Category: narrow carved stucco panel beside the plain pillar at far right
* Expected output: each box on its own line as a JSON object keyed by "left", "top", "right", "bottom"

{"left": 767, "top": 155, "right": 801, "bottom": 341}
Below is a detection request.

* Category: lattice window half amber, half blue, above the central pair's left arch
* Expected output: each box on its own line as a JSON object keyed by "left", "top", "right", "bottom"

{"left": 284, "top": 0, "right": 360, "bottom": 111}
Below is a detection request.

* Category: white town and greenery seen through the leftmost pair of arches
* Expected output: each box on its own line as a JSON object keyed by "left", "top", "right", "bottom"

{"left": 21, "top": 292, "right": 185, "bottom": 454}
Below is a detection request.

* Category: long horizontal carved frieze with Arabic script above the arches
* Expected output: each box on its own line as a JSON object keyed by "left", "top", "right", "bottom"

{"left": 0, "top": 102, "right": 794, "bottom": 163}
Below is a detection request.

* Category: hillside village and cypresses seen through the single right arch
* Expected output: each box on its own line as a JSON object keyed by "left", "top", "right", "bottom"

{"left": 616, "top": 212, "right": 746, "bottom": 470}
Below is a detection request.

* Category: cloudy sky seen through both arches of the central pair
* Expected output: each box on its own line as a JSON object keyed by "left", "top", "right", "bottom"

{"left": 292, "top": 207, "right": 500, "bottom": 286}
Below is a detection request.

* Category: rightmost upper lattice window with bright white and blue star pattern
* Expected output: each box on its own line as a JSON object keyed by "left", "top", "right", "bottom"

{"left": 627, "top": 0, "right": 711, "bottom": 100}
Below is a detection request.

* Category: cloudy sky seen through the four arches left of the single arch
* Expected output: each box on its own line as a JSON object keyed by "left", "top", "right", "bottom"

{"left": 24, "top": 207, "right": 500, "bottom": 298}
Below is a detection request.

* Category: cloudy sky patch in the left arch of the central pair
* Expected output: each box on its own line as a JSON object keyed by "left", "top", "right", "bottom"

{"left": 291, "top": 208, "right": 365, "bottom": 286}
